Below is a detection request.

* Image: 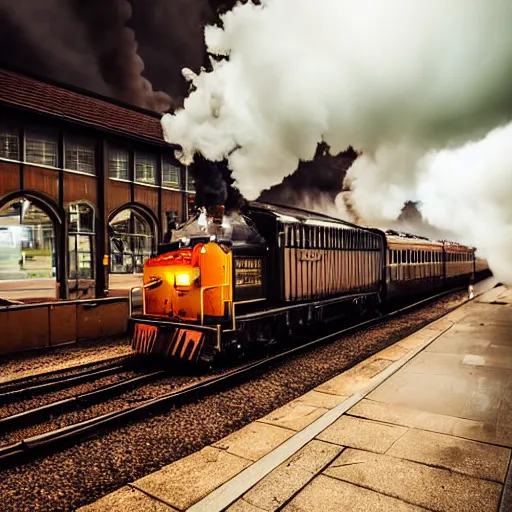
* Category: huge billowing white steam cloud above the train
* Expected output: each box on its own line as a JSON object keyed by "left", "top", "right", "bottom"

{"left": 162, "top": 0, "right": 512, "bottom": 282}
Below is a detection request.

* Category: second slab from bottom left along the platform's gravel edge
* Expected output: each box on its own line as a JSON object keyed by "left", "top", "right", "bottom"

{"left": 131, "top": 446, "right": 251, "bottom": 510}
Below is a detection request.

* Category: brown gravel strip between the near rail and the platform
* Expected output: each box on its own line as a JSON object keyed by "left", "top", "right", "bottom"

{"left": 0, "top": 292, "right": 467, "bottom": 512}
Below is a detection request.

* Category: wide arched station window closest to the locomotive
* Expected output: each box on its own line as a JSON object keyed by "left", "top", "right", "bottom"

{"left": 109, "top": 208, "right": 154, "bottom": 274}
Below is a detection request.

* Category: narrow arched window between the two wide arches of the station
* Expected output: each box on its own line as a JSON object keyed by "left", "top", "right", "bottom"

{"left": 68, "top": 203, "right": 94, "bottom": 280}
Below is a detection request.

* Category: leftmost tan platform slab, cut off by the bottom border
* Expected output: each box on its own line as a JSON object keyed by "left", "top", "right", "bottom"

{"left": 78, "top": 486, "right": 177, "bottom": 512}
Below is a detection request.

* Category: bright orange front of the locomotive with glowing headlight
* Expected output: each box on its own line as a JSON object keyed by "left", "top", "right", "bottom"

{"left": 132, "top": 237, "right": 233, "bottom": 360}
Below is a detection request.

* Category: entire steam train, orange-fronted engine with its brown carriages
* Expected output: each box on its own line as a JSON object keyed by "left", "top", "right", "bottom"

{"left": 130, "top": 202, "right": 488, "bottom": 363}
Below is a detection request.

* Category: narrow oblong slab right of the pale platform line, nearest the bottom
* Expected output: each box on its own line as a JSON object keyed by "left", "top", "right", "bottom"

{"left": 237, "top": 441, "right": 343, "bottom": 512}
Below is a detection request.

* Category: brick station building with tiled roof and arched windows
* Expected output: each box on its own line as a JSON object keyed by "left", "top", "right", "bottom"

{"left": 0, "top": 68, "right": 194, "bottom": 299}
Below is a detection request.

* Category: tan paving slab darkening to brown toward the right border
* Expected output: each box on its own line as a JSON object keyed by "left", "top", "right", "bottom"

{"left": 386, "top": 429, "right": 510, "bottom": 483}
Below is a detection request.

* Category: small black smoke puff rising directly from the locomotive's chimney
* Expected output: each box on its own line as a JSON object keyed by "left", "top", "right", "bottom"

{"left": 190, "top": 154, "right": 245, "bottom": 211}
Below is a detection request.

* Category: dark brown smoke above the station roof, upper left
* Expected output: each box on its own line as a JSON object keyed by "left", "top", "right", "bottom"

{"left": 0, "top": 0, "right": 170, "bottom": 112}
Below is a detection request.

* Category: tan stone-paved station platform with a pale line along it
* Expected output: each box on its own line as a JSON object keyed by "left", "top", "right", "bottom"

{"left": 80, "top": 280, "right": 512, "bottom": 512}
